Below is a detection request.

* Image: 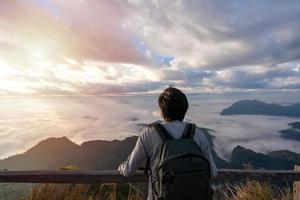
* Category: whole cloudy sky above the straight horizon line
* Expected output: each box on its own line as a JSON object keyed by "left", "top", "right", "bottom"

{"left": 0, "top": 0, "right": 300, "bottom": 96}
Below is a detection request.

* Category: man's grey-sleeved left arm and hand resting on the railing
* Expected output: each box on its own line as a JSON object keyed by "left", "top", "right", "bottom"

{"left": 118, "top": 131, "right": 147, "bottom": 176}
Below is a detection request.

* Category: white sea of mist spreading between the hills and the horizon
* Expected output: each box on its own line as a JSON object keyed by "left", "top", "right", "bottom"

{"left": 0, "top": 92, "right": 300, "bottom": 158}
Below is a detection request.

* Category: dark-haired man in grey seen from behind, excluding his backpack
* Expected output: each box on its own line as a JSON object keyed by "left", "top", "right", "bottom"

{"left": 118, "top": 87, "right": 217, "bottom": 200}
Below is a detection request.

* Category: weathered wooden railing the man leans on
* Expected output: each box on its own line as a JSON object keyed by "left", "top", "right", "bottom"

{"left": 0, "top": 169, "right": 300, "bottom": 183}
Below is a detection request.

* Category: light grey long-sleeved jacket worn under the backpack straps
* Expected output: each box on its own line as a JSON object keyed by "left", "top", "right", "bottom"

{"left": 118, "top": 121, "right": 217, "bottom": 200}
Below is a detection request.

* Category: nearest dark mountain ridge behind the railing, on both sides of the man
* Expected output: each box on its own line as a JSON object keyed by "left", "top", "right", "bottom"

{"left": 0, "top": 124, "right": 300, "bottom": 170}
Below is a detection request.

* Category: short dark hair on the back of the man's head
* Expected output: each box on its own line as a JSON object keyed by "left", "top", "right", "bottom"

{"left": 158, "top": 86, "right": 189, "bottom": 121}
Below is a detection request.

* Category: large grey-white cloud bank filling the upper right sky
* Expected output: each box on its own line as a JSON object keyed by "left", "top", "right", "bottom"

{"left": 127, "top": 0, "right": 300, "bottom": 69}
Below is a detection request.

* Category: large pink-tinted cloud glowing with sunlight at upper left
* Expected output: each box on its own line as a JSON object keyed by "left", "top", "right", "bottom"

{"left": 0, "top": 0, "right": 148, "bottom": 64}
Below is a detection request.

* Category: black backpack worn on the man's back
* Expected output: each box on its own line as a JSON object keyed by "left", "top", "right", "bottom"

{"left": 145, "top": 123, "right": 212, "bottom": 200}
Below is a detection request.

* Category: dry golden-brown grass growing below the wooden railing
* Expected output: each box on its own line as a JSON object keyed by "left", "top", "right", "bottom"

{"left": 22, "top": 181, "right": 293, "bottom": 200}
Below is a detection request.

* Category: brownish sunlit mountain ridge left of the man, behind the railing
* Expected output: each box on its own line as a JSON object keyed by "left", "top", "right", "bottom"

{"left": 0, "top": 136, "right": 137, "bottom": 170}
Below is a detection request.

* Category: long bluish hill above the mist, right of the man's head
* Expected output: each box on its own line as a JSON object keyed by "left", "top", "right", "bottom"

{"left": 221, "top": 100, "right": 300, "bottom": 117}
